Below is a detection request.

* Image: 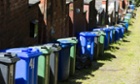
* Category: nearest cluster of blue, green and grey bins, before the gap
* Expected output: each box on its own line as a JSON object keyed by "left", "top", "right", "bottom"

{"left": 0, "top": 37, "right": 77, "bottom": 84}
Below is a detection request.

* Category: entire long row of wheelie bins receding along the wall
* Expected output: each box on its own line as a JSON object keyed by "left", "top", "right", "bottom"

{"left": 0, "top": 2, "right": 135, "bottom": 84}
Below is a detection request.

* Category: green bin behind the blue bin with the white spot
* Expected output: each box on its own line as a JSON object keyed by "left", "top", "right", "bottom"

{"left": 93, "top": 29, "right": 105, "bottom": 56}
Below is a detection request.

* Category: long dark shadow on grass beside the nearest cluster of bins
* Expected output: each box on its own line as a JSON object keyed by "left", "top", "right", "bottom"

{"left": 58, "top": 61, "right": 104, "bottom": 84}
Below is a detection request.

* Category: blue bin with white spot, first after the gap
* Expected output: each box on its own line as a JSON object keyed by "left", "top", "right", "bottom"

{"left": 79, "top": 32, "right": 97, "bottom": 61}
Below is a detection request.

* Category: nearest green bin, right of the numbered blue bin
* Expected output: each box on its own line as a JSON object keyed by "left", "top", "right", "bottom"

{"left": 30, "top": 45, "right": 51, "bottom": 84}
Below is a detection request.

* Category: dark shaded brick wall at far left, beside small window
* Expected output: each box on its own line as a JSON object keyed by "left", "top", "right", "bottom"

{"left": 0, "top": 0, "right": 38, "bottom": 49}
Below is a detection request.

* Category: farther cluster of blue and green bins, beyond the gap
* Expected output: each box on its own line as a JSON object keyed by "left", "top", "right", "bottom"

{"left": 79, "top": 24, "right": 126, "bottom": 60}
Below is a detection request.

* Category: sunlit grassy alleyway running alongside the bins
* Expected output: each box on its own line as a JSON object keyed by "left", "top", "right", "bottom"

{"left": 60, "top": 8, "right": 140, "bottom": 84}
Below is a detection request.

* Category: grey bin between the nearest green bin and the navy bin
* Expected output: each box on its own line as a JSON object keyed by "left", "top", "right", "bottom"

{"left": 43, "top": 43, "right": 61, "bottom": 84}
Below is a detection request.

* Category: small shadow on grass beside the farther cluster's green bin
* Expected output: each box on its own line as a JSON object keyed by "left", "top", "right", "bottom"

{"left": 98, "top": 52, "right": 117, "bottom": 61}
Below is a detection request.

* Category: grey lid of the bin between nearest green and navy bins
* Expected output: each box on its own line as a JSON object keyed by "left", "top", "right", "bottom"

{"left": 43, "top": 43, "right": 61, "bottom": 52}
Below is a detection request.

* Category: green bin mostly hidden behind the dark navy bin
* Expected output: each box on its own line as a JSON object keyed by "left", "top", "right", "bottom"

{"left": 58, "top": 37, "right": 78, "bottom": 75}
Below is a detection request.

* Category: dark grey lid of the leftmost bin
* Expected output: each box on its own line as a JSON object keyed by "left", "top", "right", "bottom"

{"left": 0, "top": 52, "right": 20, "bottom": 63}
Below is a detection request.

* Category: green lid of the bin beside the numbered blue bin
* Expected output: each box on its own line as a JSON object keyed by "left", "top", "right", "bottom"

{"left": 29, "top": 45, "right": 50, "bottom": 54}
